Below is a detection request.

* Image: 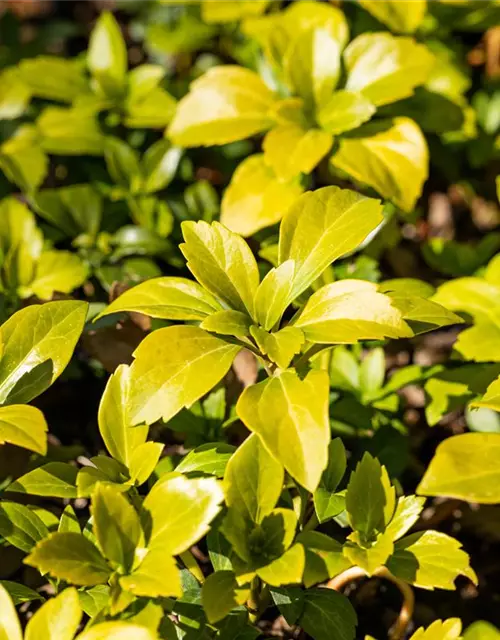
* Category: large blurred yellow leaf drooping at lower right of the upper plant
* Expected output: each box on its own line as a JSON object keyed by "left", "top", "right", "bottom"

{"left": 330, "top": 117, "right": 429, "bottom": 212}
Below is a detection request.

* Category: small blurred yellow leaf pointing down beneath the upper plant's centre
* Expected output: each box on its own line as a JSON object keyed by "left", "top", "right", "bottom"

{"left": 262, "top": 124, "right": 333, "bottom": 181}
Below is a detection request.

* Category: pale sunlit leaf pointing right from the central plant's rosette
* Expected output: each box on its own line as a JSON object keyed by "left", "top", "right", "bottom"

{"left": 294, "top": 280, "right": 413, "bottom": 344}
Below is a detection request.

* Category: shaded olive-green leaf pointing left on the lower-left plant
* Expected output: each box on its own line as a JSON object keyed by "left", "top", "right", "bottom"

{"left": 24, "top": 532, "right": 111, "bottom": 587}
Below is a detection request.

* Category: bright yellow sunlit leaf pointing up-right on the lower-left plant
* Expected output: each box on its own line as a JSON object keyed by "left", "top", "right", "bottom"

{"left": 143, "top": 476, "right": 223, "bottom": 555}
